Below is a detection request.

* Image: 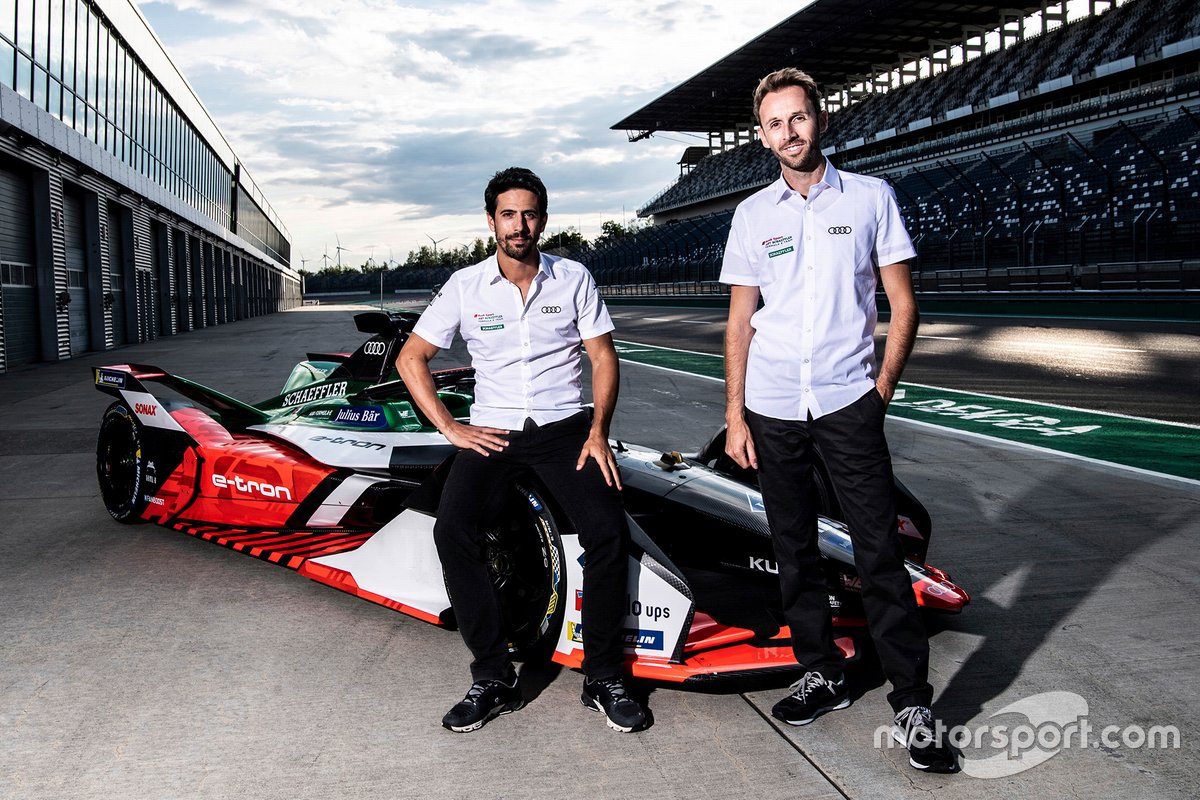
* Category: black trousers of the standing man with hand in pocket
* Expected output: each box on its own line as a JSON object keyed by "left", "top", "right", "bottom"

{"left": 746, "top": 387, "right": 934, "bottom": 711}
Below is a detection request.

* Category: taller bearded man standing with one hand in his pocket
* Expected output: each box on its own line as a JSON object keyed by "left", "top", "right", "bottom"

{"left": 721, "top": 68, "right": 958, "bottom": 772}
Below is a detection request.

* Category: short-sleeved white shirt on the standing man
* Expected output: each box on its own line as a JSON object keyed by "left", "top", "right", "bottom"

{"left": 720, "top": 161, "right": 917, "bottom": 420}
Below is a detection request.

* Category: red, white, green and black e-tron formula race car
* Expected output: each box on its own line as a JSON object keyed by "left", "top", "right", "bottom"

{"left": 94, "top": 312, "right": 970, "bottom": 682}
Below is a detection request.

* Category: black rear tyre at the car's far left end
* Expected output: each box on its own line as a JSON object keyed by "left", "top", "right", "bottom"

{"left": 96, "top": 403, "right": 148, "bottom": 524}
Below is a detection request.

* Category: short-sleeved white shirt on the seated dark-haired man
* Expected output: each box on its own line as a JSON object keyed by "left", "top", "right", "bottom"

{"left": 413, "top": 253, "right": 613, "bottom": 431}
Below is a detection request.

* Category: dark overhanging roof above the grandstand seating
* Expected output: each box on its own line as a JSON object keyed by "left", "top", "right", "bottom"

{"left": 612, "top": 0, "right": 1042, "bottom": 134}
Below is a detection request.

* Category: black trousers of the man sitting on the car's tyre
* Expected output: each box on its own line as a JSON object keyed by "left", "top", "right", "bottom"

{"left": 433, "top": 411, "right": 629, "bottom": 680}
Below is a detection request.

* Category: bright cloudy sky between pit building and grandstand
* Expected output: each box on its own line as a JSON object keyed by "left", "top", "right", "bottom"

{"left": 137, "top": 0, "right": 808, "bottom": 271}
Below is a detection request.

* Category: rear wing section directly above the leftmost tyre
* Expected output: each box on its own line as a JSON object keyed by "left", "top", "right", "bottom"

{"left": 92, "top": 363, "right": 270, "bottom": 429}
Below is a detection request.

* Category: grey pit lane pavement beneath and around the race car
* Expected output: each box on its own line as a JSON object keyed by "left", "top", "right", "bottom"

{"left": 0, "top": 307, "right": 1200, "bottom": 800}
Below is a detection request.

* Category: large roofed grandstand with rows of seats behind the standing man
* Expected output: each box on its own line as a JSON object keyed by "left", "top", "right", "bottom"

{"left": 592, "top": 0, "right": 1200, "bottom": 294}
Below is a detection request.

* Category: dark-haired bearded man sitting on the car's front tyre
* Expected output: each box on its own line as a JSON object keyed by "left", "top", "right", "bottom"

{"left": 396, "top": 167, "right": 647, "bottom": 733}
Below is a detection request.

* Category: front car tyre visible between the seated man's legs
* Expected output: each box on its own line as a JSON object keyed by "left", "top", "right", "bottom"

{"left": 485, "top": 483, "right": 566, "bottom": 661}
